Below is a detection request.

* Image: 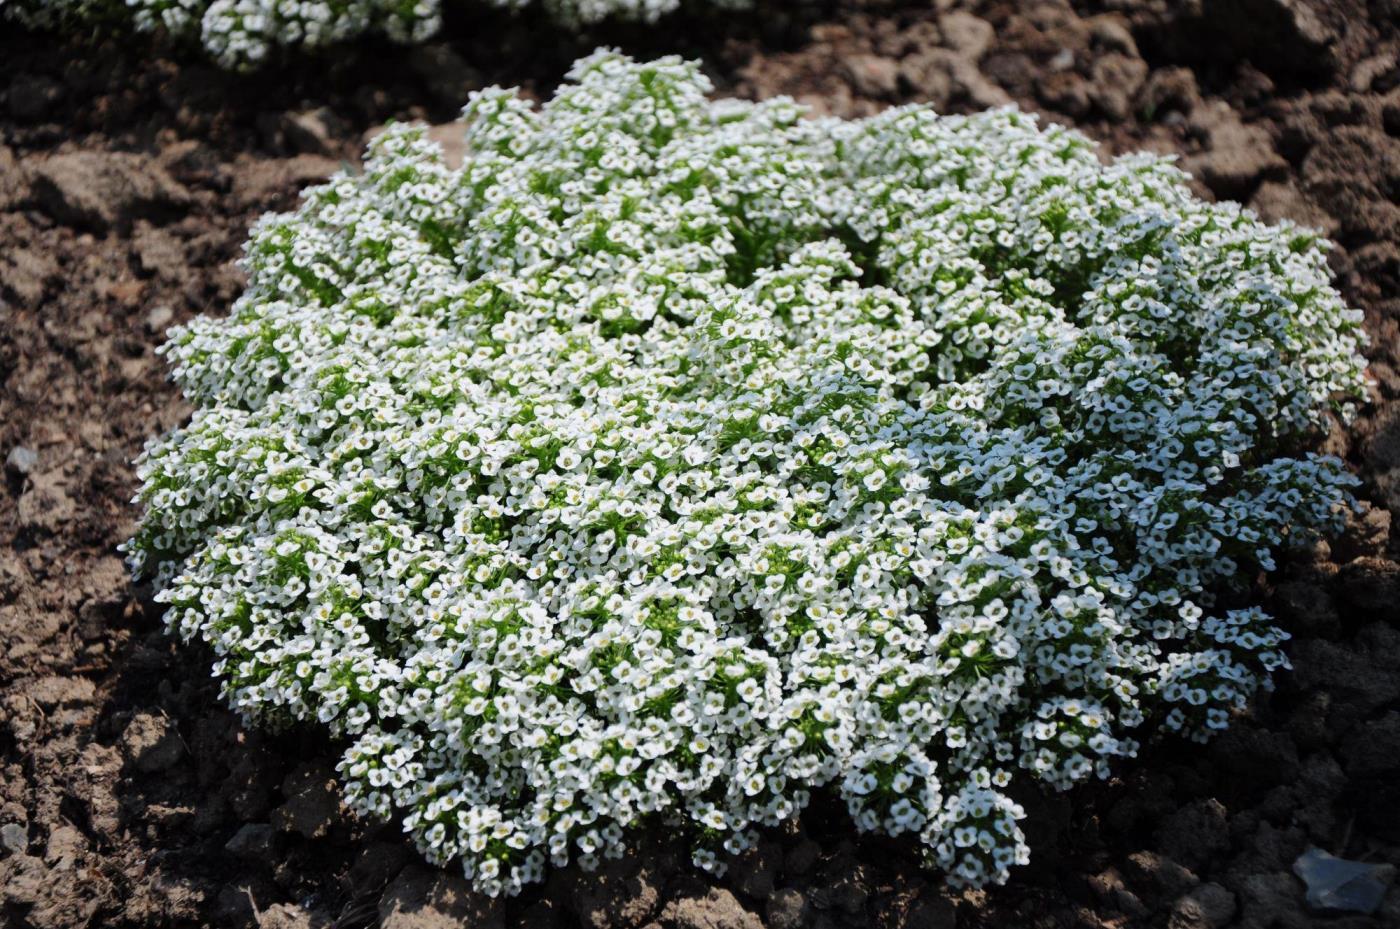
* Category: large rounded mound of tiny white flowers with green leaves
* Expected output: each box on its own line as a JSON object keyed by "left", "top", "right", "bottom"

{"left": 129, "top": 53, "right": 1364, "bottom": 894}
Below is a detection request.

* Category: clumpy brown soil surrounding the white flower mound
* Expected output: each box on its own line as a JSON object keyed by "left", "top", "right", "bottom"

{"left": 0, "top": 0, "right": 1400, "bottom": 929}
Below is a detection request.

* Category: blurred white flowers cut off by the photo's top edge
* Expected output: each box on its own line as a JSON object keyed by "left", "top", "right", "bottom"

{"left": 0, "top": 0, "right": 752, "bottom": 69}
